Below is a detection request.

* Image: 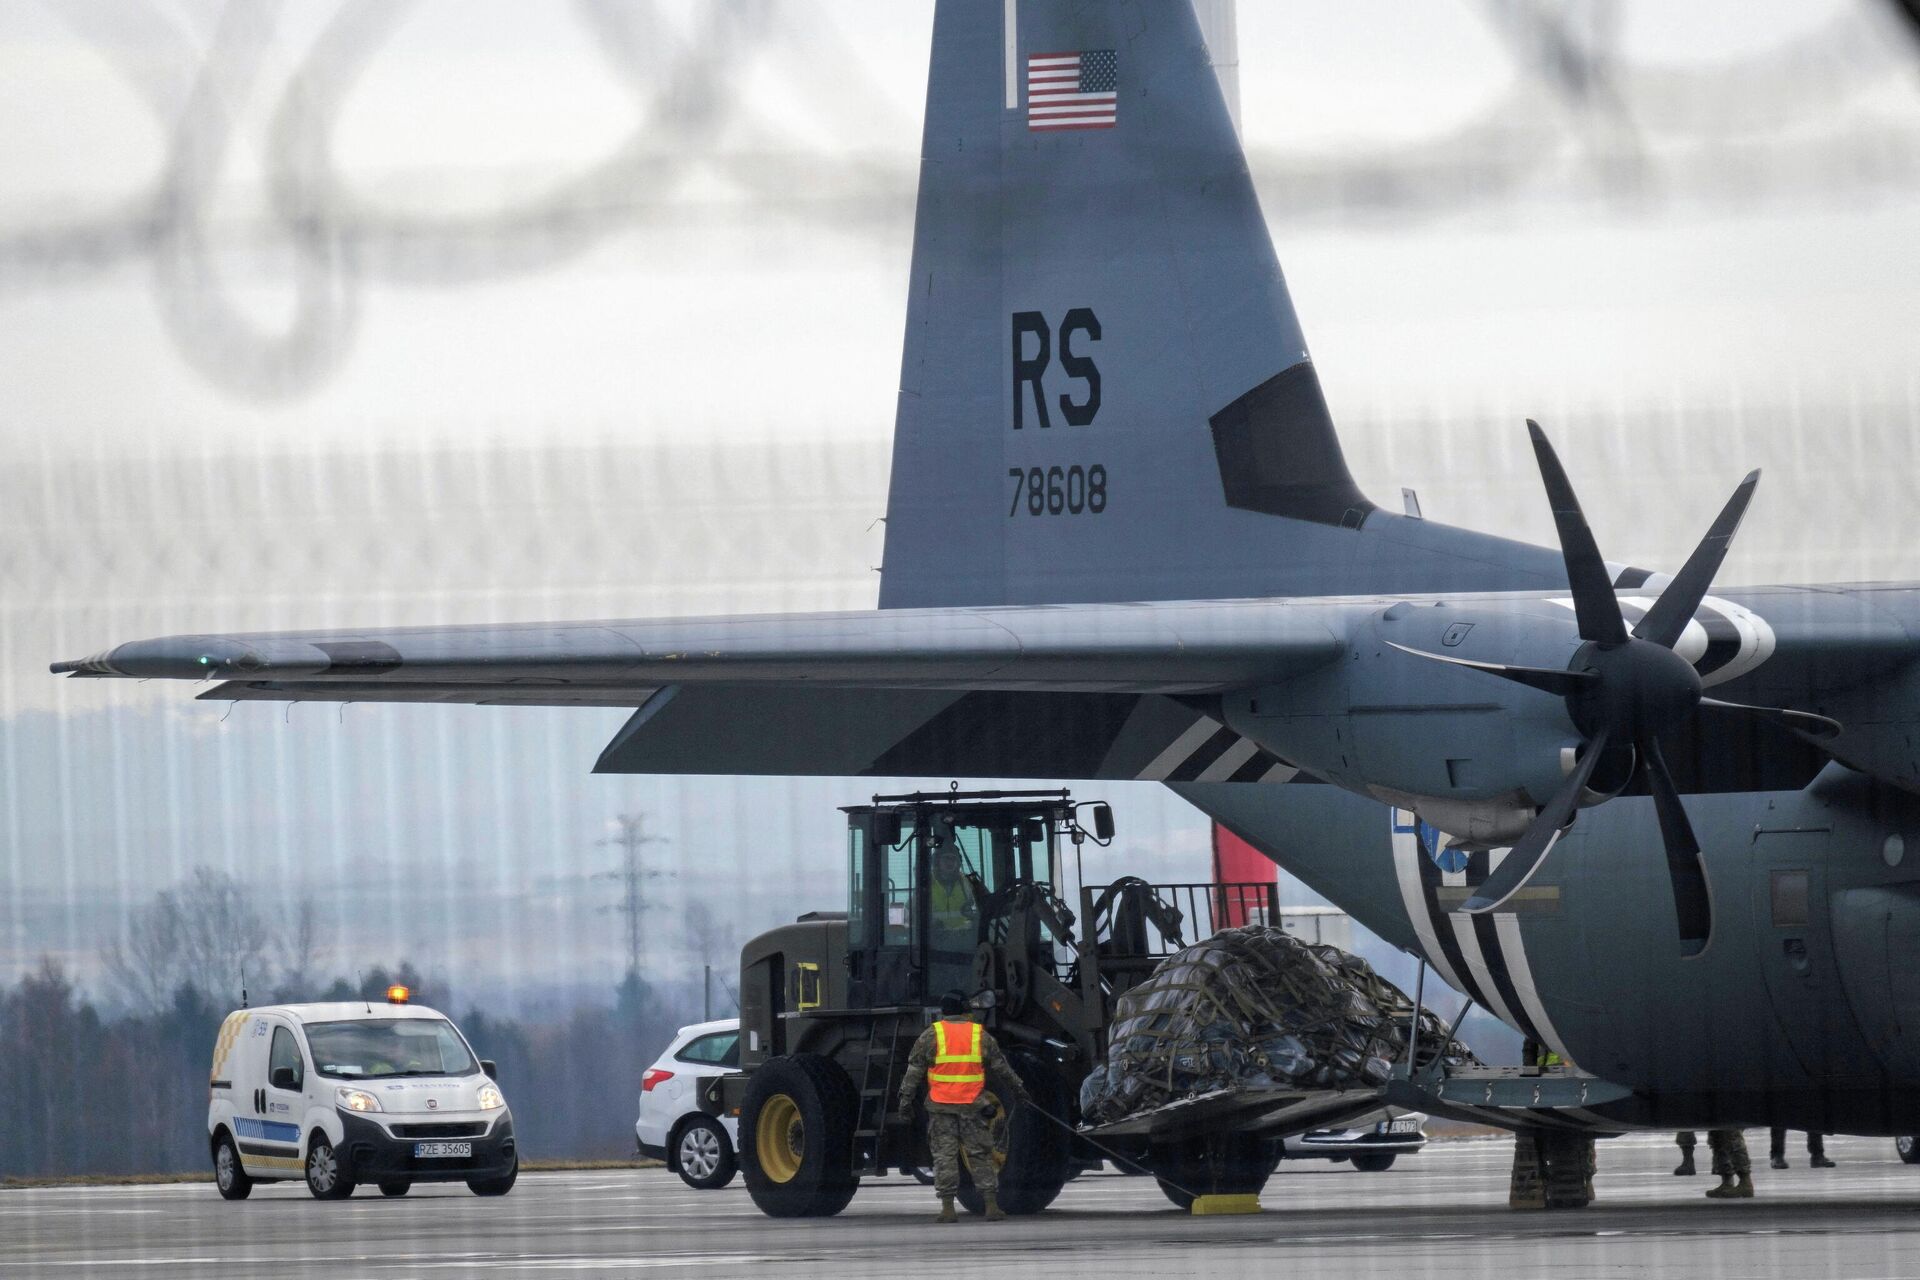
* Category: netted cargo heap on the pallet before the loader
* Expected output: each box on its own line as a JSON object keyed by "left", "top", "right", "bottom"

{"left": 1081, "top": 925, "right": 1478, "bottom": 1125}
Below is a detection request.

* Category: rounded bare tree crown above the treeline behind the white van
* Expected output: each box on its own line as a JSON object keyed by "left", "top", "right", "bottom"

{"left": 108, "top": 867, "right": 269, "bottom": 1013}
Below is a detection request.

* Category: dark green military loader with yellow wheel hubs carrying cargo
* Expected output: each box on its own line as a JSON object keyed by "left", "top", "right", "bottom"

{"left": 703, "top": 791, "right": 1275, "bottom": 1217}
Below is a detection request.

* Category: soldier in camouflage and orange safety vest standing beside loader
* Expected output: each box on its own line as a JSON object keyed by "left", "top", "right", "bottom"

{"left": 899, "top": 990, "right": 1029, "bottom": 1222}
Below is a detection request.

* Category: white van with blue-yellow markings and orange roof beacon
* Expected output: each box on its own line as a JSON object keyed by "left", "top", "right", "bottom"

{"left": 207, "top": 986, "right": 520, "bottom": 1199}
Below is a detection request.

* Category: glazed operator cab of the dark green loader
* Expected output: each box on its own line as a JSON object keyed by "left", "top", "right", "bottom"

{"left": 845, "top": 791, "right": 1112, "bottom": 1007}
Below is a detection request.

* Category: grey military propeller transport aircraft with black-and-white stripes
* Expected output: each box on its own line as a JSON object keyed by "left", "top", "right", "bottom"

{"left": 54, "top": 0, "right": 1920, "bottom": 1134}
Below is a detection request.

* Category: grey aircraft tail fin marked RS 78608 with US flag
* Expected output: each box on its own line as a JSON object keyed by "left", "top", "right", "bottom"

{"left": 879, "top": 0, "right": 1551, "bottom": 608}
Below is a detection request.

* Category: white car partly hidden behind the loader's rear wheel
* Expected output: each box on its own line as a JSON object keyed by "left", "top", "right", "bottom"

{"left": 634, "top": 1017, "right": 739, "bottom": 1192}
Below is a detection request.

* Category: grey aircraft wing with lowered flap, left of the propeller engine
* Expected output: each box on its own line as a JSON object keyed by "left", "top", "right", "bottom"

{"left": 54, "top": 601, "right": 1344, "bottom": 781}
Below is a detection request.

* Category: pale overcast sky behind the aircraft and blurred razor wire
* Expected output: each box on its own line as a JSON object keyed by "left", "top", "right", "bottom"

{"left": 0, "top": 0, "right": 1920, "bottom": 981}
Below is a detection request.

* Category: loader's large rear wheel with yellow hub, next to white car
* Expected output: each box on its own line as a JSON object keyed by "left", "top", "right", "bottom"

{"left": 739, "top": 1054, "right": 860, "bottom": 1219}
